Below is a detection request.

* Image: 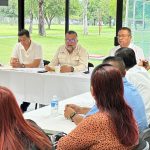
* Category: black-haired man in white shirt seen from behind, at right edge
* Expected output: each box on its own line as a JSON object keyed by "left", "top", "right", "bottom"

{"left": 115, "top": 48, "right": 150, "bottom": 123}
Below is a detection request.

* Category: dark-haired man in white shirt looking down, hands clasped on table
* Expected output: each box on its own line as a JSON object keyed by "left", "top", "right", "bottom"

{"left": 10, "top": 29, "right": 44, "bottom": 112}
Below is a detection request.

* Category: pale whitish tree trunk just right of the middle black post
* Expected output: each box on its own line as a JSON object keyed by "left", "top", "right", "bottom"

{"left": 83, "top": 0, "right": 88, "bottom": 35}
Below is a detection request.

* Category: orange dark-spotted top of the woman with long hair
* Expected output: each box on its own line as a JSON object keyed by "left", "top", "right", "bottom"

{"left": 57, "top": 112, "right": 132, "bottom": 150}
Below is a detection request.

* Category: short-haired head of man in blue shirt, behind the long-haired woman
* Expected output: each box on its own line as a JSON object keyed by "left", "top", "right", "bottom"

{"left": 102, "top": 56, "right": 125, "bottom": 76}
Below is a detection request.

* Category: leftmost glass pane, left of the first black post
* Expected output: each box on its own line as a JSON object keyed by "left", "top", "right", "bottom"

{"left": 0, "top": 0, "right": 18, "bottom": 64}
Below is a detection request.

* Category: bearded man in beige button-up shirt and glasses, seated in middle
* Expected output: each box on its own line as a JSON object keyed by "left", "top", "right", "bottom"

{"left": 45, "top": 31, "right": 88, "bottom": 72}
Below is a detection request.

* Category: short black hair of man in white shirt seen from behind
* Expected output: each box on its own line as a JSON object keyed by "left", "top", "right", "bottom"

{"left": 115, "top": 47, "right": 137, "bottom": 69}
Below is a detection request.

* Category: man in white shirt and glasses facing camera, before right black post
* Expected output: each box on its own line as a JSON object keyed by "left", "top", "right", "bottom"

{"left": 110, "top": 27, "right": 144, "bottom": 62}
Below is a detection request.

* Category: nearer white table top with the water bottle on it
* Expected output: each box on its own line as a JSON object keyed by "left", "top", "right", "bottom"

{"left": 24, "top": 92, "right": 95, "bottom": 133}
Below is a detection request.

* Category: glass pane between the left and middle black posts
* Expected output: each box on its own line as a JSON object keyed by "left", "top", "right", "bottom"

{"left": 25, "top": 0, "right": 65, "bottom": 60}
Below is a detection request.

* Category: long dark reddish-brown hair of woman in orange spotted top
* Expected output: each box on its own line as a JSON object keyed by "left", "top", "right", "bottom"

{"left": 91, "top": 64, "right": 138, "bottom": 146}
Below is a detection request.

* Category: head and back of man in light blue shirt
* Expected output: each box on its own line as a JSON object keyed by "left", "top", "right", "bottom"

{"left": 103, "top": 56, "right": 148, "bottom": 131}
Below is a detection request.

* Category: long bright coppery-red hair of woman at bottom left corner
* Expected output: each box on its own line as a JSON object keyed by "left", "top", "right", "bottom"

{"left": 0, "top": 86, "right": 51, "bottom": 150}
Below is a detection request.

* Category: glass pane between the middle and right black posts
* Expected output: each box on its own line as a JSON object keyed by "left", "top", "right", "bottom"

{"left": 70, "top": 0, "right": 116, "bottom": 64}
